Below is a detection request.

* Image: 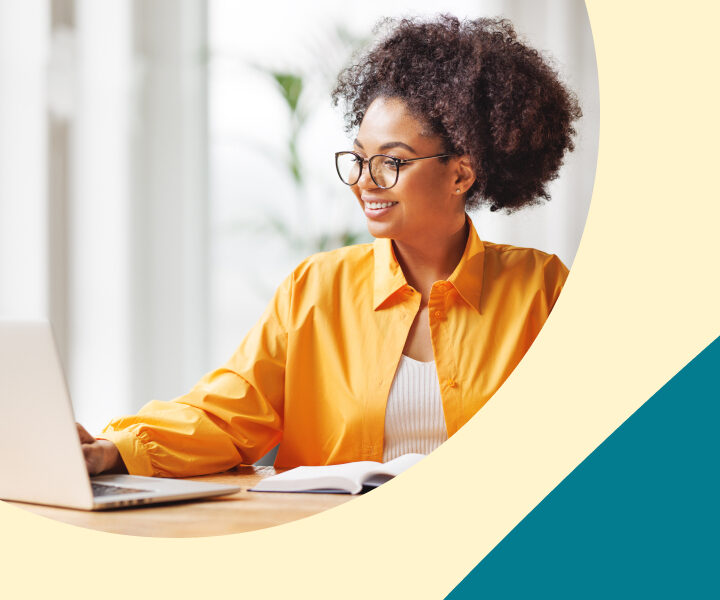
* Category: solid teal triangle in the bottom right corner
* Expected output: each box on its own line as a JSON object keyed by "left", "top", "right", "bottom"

{"left": 447, "top": 338, "right": 720, "bottom": 600}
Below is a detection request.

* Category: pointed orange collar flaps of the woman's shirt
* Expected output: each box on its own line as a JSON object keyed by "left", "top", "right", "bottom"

{"left": 373, "top": 214, "right": 485, "bottom": 312}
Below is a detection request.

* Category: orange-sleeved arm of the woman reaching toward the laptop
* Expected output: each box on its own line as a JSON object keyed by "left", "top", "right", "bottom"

{"left": 100, "top": 275, "right": 293, "bottom": 477}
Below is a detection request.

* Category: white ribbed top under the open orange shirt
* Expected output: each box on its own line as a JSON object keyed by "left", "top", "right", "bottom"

{"left": 383, "top": 354, "right": 447, "bottom": 462}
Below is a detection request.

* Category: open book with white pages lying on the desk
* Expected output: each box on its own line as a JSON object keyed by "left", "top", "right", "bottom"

{"left": 248, "top": 454, "right": 425, "bottom": 494}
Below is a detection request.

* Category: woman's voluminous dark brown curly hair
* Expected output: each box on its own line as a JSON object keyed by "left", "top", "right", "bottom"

{"left": 332, "top": 15, "right": 582, "bottom": 212}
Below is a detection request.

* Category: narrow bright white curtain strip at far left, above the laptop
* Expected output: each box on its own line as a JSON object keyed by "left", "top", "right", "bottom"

{"left": 0, "top": 0, "right": 49, "bottom": 315}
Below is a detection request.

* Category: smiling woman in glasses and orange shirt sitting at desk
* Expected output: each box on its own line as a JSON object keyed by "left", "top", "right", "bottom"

{"left": 78, "top": 16, "right": 580, "bottom": 476}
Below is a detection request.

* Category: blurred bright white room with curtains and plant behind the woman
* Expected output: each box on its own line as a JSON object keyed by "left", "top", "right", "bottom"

{"left": 0, "top": 0, "right": 599, "bottom": 440}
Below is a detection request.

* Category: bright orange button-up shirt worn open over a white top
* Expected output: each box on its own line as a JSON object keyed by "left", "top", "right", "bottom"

{"left": 100, "top": 217, "right": 568, "bottom": 477}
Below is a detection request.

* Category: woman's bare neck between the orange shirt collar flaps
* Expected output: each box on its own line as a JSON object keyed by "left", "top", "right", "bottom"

{"left": 393, "top": 215, "right": 470, "bottom": 303}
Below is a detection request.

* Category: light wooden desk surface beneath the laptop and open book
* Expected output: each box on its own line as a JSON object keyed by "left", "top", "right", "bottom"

{"left": 5, "top": 467, "right": 355, "bottom": 537}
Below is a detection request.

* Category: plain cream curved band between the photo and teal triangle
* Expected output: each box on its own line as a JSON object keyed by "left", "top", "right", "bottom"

{"left": 0, "top": 0, "right": 720, "bottom": 598}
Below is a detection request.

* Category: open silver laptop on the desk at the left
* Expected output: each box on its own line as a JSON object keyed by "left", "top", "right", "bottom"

{"left": 0, "top": 320, "right": 241, "bottom": 510}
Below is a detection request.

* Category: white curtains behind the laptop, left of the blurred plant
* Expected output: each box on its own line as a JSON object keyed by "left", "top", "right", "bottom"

{"left": 0, "top": 0, "right": 209, "bottom": 431}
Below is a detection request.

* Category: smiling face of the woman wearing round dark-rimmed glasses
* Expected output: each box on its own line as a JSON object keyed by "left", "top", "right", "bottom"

{"left": 351, "top": 98, "right": 469, "bottom": 243}
